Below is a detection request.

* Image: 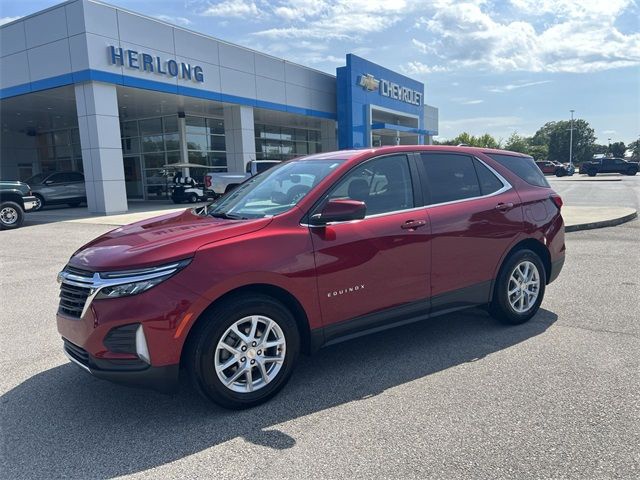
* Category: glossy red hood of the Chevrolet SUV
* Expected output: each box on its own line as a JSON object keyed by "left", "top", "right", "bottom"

{"left": 69, "top": 210, "right": 271, "bottom": 271}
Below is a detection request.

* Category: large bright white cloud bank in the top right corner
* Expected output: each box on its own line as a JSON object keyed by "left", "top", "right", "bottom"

{"left": 413, "top": 0, "right": 640, "bottom": 73}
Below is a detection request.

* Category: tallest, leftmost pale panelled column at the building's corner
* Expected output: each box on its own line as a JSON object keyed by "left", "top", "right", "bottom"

{"left": 75, "top": 82, "right": 128, "bottom": 214}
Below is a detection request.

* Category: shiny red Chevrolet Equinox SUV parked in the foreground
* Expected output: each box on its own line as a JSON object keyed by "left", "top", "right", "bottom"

{"left": 57, "top": 146, "right": 565, "bottom": 408}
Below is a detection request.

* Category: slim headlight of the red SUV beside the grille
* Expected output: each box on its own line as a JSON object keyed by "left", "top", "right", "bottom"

{"left": 95, "top": 259, "right": 191, "bottom": 299}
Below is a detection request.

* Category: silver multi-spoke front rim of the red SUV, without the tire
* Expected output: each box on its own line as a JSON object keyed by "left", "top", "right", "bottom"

{"left": 214, "top": 315, "right": 287, "bottom": 393}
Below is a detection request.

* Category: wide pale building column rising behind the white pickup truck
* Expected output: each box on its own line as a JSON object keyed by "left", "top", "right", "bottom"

{"left": 224, "top": 105, "right": 256, "bottom": 173}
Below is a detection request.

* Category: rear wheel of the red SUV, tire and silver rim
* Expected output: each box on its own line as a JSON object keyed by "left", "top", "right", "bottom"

{"left": 489, "top": 249, "right": 547, "bottom": 325}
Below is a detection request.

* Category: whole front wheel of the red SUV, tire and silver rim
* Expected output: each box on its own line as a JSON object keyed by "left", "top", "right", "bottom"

{"left": 186, "top": 295, "right": 300, "bottom": 409}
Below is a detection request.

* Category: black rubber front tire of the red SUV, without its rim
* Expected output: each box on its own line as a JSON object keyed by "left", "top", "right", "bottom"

{"left": 185, "top": 294, "right": 300, "bottom": 409}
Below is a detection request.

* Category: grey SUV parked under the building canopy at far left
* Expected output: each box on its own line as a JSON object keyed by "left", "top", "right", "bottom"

{"left": 27, "top": 172, "right": 87, "bottom": 210}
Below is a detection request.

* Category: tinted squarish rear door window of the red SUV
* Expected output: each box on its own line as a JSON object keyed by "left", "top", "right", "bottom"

{"left": 420, "top": 153, "right": 480, "bottom": 204}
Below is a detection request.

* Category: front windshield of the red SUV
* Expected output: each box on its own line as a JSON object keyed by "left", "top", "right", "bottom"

{"left": 208, "top": 158, "right": 344, "bottom": 219}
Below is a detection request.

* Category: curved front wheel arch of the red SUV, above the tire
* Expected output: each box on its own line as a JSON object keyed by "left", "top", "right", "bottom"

{"left": 180, "top": 283, "right": 312, "bottom": 364}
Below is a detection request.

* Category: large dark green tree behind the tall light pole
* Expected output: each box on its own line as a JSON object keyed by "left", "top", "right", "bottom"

{"left": 531, "top": 119, "right": 596, "bottom": 162}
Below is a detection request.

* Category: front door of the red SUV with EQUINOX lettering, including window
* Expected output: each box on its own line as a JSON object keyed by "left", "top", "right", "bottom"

{"left": 311, "top": 154, "right": 431, "bottom": 328}
